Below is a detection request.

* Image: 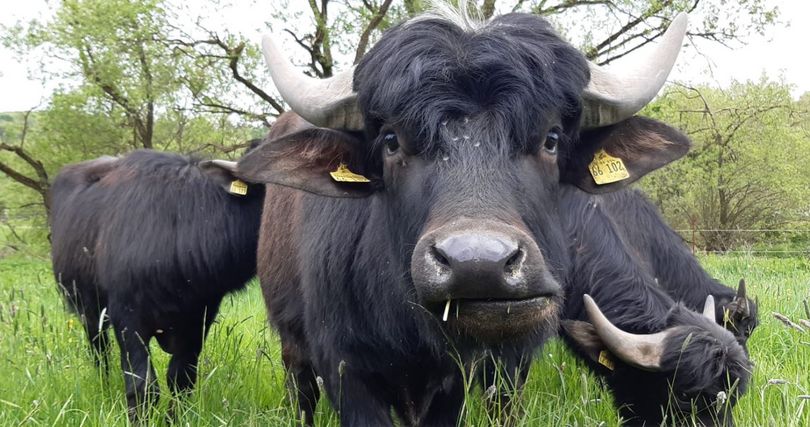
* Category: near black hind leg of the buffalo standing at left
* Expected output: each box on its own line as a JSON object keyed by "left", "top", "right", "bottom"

{"left": 114, "top": 322, "right": 160, "bottom": 421}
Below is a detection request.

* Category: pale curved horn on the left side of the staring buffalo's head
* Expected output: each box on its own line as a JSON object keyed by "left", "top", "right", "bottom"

{"left": 262, "top": 36, "right": 364, "bottom": 130}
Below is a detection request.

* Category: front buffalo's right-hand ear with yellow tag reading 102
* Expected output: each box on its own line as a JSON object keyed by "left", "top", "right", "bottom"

{"left": 561, "top": 116, "right": 691, "bottom": 193}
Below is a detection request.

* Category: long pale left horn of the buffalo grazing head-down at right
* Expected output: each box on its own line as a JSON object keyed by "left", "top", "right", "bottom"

{"left": 582, "top": 294, "right": 669, "bottom": 371}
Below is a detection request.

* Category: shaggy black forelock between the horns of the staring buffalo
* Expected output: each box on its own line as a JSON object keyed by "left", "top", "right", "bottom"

{"left": 354, "top": 9, "right": 589, "bottom": 154}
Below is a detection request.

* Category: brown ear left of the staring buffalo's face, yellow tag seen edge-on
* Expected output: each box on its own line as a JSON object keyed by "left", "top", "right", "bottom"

{"left": 236, "top": 128, "right": 379, "bottom": 198}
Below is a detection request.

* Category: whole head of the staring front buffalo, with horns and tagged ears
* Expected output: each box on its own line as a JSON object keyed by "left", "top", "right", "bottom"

{"left": 239, "top": 7, "right": 689, "bottom": 343}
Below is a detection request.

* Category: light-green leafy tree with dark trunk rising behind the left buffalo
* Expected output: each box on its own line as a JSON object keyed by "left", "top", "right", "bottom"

{"left": 4, "top": 0, "right": 283, "bottom": 148}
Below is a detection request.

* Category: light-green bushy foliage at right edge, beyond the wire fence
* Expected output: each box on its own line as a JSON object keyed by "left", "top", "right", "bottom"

{"left": 644, "top": 79, "right": 810, "bottom": 250}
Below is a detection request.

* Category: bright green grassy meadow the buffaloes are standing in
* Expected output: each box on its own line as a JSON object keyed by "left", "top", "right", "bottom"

{"left": 0, "top": 256, "right": 810, "bottom": 426}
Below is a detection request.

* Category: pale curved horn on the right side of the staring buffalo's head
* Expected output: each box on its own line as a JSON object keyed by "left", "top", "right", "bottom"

{"left": 582, "top": 12, "right": 688, "bottom": 128}
